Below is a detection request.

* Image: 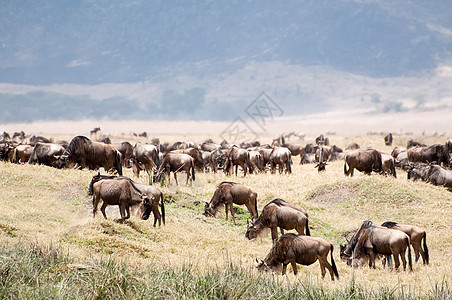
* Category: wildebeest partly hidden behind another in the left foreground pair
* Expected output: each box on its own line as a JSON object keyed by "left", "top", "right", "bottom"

{"left": 88, "top": 173, "right": 165, "bottom": 227}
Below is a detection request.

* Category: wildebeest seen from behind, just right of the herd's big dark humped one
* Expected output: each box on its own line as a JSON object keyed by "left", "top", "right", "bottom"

{"left": 132, "top": 142, "right": 159, "bottom": 177}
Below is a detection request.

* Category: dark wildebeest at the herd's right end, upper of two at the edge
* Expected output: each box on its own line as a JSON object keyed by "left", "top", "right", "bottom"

{"left": 407, "top": 144, "right": 450, "bottom": 166}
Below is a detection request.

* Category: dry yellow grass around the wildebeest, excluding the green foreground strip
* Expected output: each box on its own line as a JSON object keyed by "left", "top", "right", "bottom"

{"left": 0, "top": 136, "right": 452, "bottom": 294}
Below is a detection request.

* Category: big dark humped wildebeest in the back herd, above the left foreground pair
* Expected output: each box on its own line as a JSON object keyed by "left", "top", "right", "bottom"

{"left": 56, "top": 136, "right": 122, "bottom": 175}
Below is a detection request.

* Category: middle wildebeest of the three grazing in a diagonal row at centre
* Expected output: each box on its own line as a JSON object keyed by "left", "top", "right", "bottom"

{"left": 245, "top": 199, "right": 311, "bottom": 243}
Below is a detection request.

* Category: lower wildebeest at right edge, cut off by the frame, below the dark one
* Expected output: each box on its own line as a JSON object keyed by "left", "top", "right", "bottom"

{"left": 407, "top": 163, "right": 452, "bottom": 191}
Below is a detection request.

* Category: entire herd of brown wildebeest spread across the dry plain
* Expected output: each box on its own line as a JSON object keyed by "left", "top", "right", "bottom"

{"left": 0, "top": 132, "right": 452, "bottom": 280}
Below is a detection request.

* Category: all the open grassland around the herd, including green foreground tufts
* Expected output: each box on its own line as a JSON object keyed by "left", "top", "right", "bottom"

{"left": 0, "top": 136, "right": 452, "bottom": 299}
